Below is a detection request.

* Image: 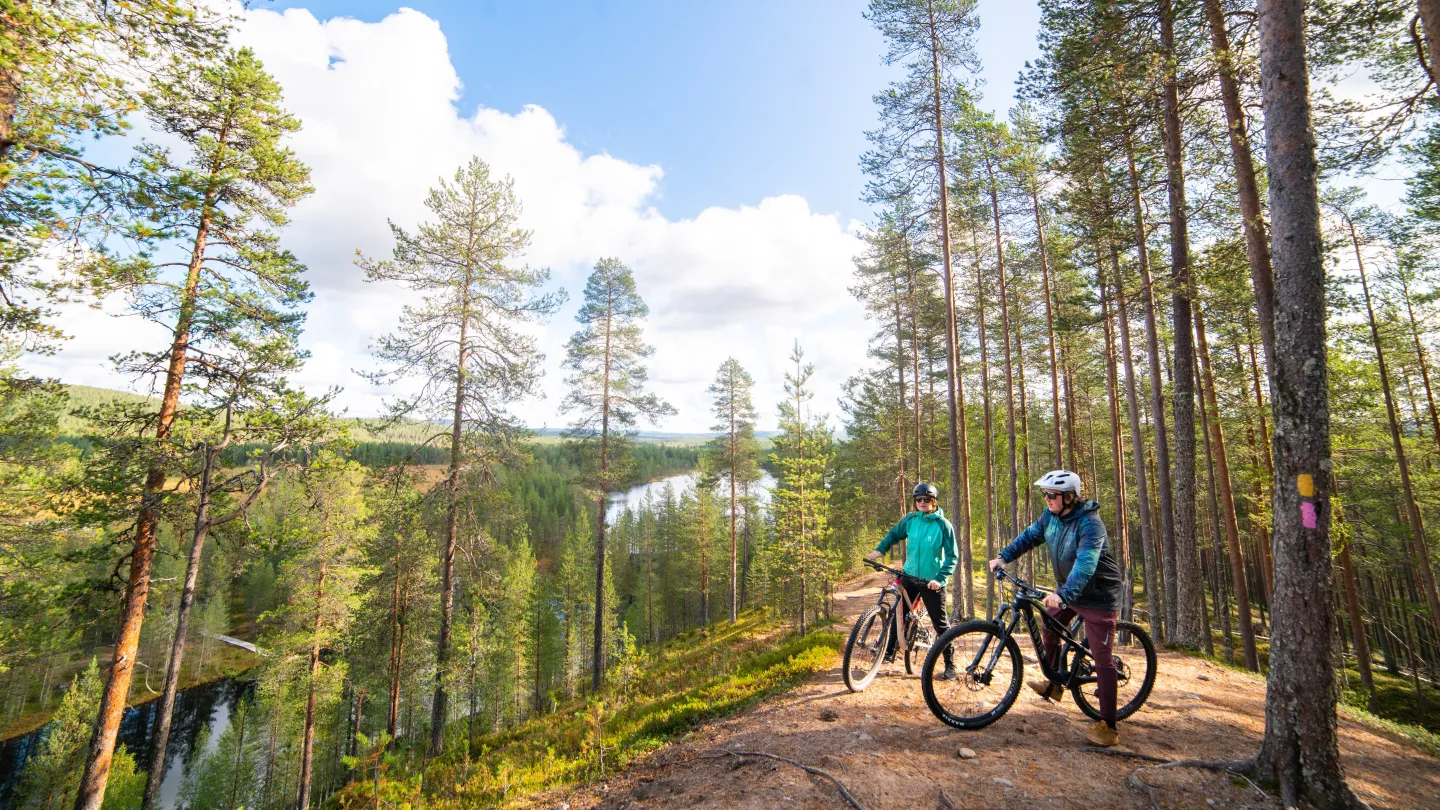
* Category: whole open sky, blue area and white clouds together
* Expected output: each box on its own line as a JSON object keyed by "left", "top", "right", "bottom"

{"left": 39, "top": 0, "right": 1038, "bottom": 431}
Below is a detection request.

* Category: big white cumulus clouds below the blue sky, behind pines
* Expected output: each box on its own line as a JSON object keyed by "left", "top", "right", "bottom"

{"left": 30, "top": 9, "right": 868, "bottom": 431}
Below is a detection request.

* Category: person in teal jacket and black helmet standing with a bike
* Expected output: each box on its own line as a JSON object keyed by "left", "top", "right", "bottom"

{"left": 868, "top": 483, "right": 960, "bottom": 680}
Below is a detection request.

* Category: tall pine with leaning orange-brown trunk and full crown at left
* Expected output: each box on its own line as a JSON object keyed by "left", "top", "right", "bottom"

{"left": 75, "top": 49, "right": 311, "bottom": 810}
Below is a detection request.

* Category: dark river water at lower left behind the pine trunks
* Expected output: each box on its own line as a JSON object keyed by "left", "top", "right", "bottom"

{"left": 0, "top": 679, "right": 253, "bottom": 810}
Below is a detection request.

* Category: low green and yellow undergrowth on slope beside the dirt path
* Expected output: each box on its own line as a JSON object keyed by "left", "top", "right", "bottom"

{"left": 336, "top": 611, "right": 844, "bottom": 809}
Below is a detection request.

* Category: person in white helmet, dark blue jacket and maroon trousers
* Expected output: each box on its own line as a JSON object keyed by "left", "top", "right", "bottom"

{"left": 989, "top": 470, "right": 1125, "bottom": 747}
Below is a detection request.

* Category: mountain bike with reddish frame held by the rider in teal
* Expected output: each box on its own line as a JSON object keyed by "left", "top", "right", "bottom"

{"left": 842, "top": 559, "right": 935, "bottom": 692}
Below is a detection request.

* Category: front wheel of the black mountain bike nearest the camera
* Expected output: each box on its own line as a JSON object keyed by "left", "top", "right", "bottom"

{"left": 920, "top": 620, "right": 1022, "bottom": 731}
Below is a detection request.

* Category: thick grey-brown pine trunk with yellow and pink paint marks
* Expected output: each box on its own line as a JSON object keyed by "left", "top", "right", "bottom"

{"left": 1257, "top": 0, "right": 1362, "bottom": 795}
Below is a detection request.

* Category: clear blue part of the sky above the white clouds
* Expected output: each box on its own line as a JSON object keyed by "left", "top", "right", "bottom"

{"left": 262, "top": 0, "right": 1040, "bottom": 219}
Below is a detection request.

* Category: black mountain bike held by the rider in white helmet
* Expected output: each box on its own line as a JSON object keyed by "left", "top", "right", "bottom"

{"left": 920, "top": 568, "right": 1155, "bottom": 729}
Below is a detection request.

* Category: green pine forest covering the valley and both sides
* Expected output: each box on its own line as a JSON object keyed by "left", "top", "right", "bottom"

{"left": 0, "top": 0, "right": 1440, "bottom": 810}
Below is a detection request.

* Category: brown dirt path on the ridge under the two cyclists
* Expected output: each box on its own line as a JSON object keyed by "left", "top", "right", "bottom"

{"left": 554, "top": 575, "right": 1440, "bottom": 810}
